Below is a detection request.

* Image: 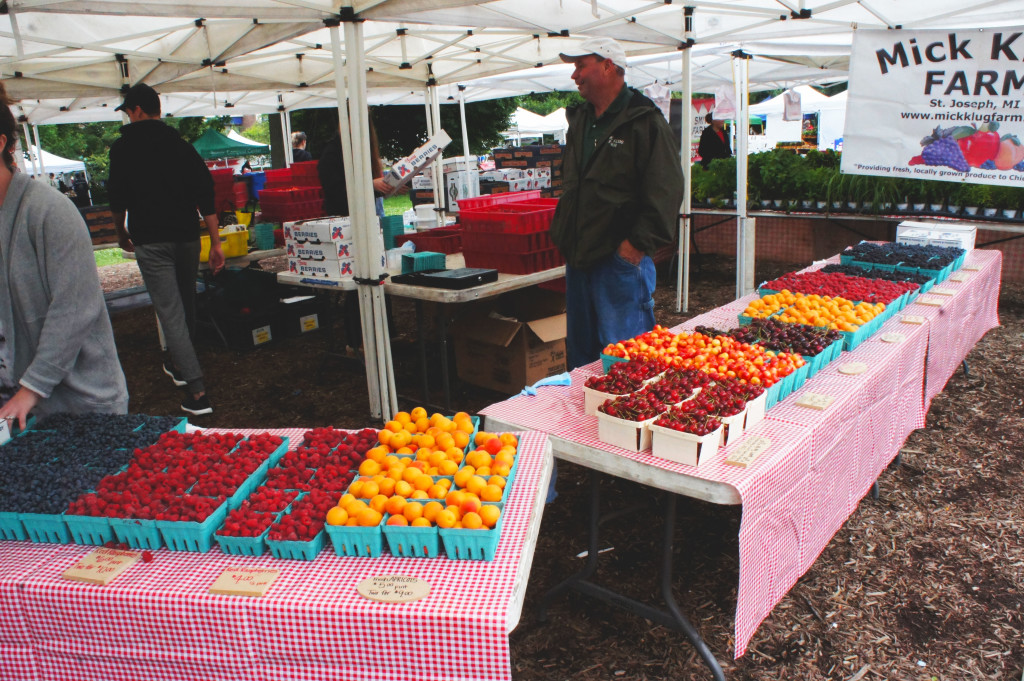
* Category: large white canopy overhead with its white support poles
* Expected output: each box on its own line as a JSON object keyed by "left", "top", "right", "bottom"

{"left": 6, "top": 0, "right": 1024, "bottom": 426}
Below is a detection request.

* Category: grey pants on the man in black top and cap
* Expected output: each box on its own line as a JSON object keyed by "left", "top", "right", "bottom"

{"left": 135, "top": 239, "right": 206, "bottom": 394}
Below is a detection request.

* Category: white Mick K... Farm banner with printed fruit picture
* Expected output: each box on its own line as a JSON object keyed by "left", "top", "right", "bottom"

{"left": 842, "top": 27, "right": 1024, "bottom": 186}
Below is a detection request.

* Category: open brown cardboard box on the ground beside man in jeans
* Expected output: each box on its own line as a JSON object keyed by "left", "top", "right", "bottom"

{"left": 452, "top": 291, "right": 565, "bottom": 393}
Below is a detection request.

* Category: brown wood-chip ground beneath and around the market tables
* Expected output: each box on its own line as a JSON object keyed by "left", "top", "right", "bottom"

{"left": 101, "top": 251, "right": 1024, "bottom": 681}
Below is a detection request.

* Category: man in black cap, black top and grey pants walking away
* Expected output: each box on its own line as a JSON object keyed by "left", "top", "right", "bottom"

{"left": 106, "top": 83, "right": 224, "bottom": 415}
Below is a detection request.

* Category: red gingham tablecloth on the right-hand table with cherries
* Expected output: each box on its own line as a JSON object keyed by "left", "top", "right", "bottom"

{"left": 481, "top": 251, "right": 1001, "bottom": 657}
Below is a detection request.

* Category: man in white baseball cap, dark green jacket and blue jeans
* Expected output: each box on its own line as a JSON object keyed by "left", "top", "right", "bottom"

{"left": 551, "top": 38, "right": 683, "bottom": 369}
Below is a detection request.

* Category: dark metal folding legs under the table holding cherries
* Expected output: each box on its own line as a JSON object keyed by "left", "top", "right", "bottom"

{"left": 539, "top": 471, "right": 725, "bottom": 681}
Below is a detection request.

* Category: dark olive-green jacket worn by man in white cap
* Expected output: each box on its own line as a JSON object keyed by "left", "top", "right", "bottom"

{"left": 551, "top": 90, "right": 683, "bottom": 269}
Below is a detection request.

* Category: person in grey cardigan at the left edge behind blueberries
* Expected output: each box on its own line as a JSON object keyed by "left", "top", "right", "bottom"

{"left": 0, "top": 83, "right": 128, "bottom": 429}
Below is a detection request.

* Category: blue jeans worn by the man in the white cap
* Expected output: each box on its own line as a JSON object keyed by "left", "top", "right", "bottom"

{"left": 565, "top": 253, "right": 655, "bottom": 370}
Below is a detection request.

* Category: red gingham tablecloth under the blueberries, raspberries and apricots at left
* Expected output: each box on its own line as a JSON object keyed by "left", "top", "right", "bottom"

{"left": 0, "top": 429, "right": 550, "bottom": 681}
